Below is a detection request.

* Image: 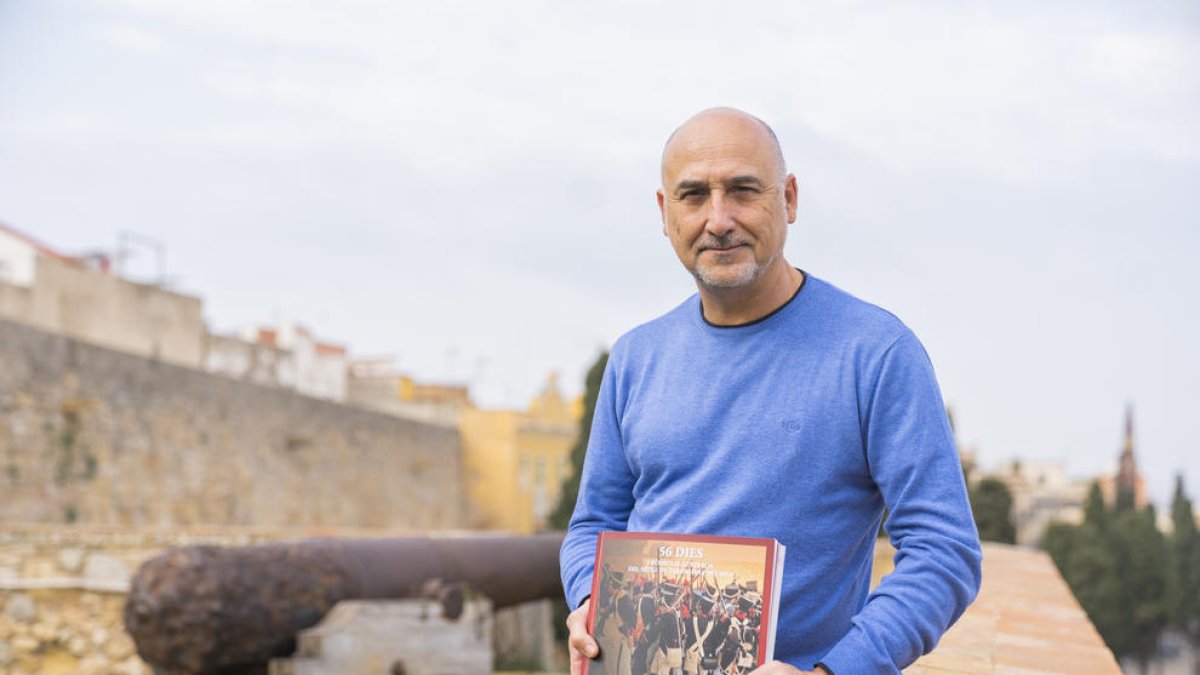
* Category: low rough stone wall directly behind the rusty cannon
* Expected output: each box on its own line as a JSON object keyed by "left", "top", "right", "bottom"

{"left": 0, "top": 524, "right": 562, "bottom": 675}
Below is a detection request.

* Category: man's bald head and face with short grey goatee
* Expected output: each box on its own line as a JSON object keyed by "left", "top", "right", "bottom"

{"left": 658, "top": 114, "right": 797, "bottom": 288}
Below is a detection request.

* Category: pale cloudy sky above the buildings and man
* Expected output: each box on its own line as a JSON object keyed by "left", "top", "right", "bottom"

{"left": 0, "top": 0, "right": 1200, "bottom": 506}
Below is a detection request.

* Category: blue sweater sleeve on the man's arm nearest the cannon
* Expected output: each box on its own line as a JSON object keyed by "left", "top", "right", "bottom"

{"left": 559, "top": 353, "right": 634, "bottom": 609}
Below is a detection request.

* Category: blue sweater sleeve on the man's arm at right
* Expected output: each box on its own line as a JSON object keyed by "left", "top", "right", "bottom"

{"left": 820, "top": 331, "right": 982, "bottom": 675}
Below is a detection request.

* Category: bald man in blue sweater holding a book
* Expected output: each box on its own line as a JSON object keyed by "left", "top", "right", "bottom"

{"left": 560, "top": 108, "right": 980, "bottom": 675}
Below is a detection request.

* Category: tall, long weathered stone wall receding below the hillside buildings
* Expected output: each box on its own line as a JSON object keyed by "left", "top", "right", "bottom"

{"left": 0, "top": 319, "right": 466, "bottom": 531}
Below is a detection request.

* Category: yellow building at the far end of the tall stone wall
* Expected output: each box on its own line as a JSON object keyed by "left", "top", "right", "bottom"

{"left": 458, "top": 375, "right": 582, "bottom": 533}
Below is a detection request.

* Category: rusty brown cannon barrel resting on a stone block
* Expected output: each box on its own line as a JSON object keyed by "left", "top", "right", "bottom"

{"left": 125, "top": 533, "right": 563, "bottom": 675}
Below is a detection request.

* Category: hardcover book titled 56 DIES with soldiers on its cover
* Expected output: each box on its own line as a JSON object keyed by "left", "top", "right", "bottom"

{"left": 583, "top": 532, "right": 785, "bottom": 675}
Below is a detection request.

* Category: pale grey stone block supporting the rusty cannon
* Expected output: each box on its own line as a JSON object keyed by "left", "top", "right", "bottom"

{"left": 270, "top": 599, "right": 492, "bottom": 675}
